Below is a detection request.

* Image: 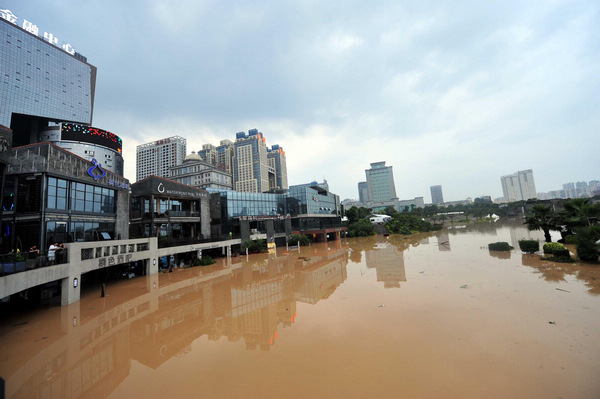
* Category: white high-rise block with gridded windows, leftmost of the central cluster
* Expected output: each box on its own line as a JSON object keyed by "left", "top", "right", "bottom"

{"left": 136, "top": 136, "right": 186, "bottom": 181}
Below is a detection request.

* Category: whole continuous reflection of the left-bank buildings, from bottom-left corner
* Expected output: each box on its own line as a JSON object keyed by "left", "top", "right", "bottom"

{"left": 0, "top": 244, "right": 348, "bottom": 398}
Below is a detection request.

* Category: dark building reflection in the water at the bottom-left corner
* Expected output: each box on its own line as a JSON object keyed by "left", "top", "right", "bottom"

{"left": 0, "top": 282, "right": 155, "bottom": 398}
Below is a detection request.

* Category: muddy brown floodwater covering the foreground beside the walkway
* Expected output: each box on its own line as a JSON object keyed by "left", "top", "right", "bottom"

{"left": 0, "top": 223, "right": 600, "bottom": 399}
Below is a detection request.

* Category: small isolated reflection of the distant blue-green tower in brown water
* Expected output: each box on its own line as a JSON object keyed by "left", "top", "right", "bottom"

{"left": 365, "top": 241, "right": 406, "bottom": 288}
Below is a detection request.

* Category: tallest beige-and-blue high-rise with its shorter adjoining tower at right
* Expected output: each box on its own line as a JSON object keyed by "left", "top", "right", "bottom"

{"left": 233, "top": 129, "right": 288, "bottom": 193}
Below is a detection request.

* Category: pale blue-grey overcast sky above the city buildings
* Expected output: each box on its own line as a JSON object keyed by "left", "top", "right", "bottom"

{"left": 0, "top": 0, "right": 600, "bottom": 202}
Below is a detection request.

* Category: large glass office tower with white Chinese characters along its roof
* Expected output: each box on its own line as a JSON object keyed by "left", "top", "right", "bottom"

{"left": 0, "top": 10, "right": 96, "bottom": 147}
